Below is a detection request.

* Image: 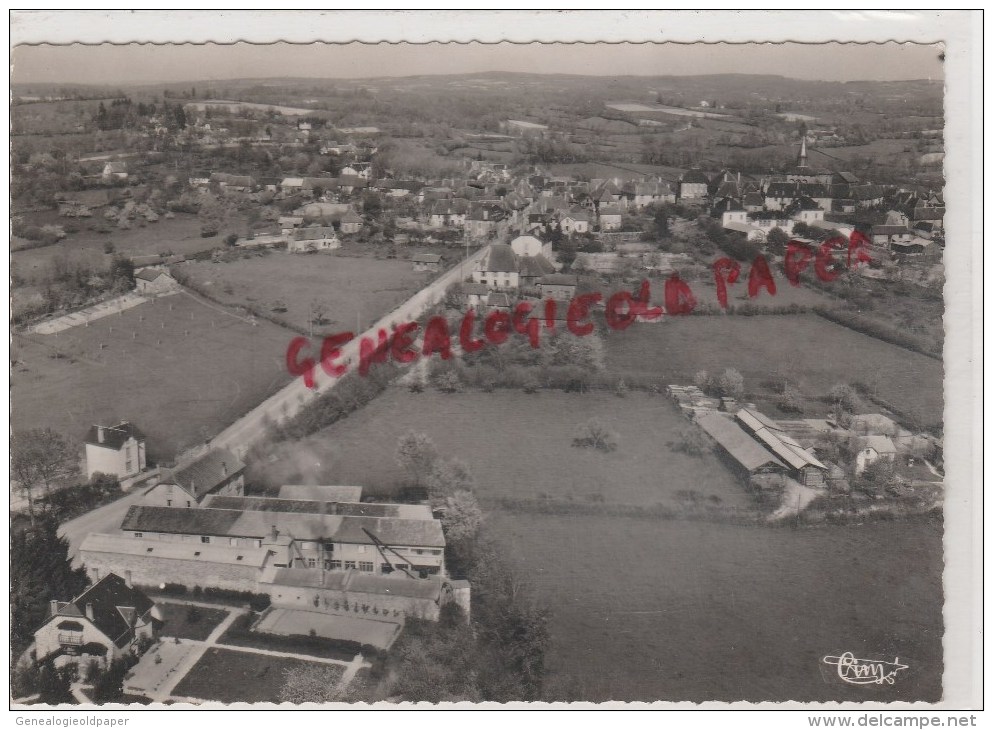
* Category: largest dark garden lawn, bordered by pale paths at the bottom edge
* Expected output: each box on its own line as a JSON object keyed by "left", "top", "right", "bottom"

{"left": 173, "top": 648, "right": 344, "bottom": 702}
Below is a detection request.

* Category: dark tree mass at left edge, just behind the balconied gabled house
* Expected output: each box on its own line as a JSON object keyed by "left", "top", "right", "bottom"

{"left": 10, "top": 516, "right": 89, "bottom": 655}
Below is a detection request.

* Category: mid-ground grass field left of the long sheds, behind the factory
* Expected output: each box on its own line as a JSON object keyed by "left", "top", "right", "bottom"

{"left": 252, "top": 388, "right": 748, "bottom": 506}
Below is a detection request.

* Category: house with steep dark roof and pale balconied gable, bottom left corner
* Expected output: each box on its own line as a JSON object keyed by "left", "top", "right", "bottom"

{"left": 34, "top": 573, "right": 159, "bottom": 663}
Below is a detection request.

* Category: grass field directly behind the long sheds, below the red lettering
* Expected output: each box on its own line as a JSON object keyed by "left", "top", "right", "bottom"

{"left": 607, "top": 315, "right": 943, "bottom": 425}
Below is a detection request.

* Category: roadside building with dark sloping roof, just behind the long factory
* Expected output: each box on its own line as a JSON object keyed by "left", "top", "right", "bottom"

{"left": 142, "top": 449, "right": 246, "bottom": 508}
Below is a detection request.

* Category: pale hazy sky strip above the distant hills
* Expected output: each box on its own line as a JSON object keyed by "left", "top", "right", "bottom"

{"left": 12, "top": 43, "right": 942, "bottom": 85}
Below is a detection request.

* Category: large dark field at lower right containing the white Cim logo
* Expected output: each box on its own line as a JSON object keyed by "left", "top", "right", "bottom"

{"left": 488, "top": 512, "right": 943, "bottom": 702}
